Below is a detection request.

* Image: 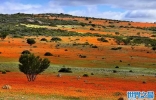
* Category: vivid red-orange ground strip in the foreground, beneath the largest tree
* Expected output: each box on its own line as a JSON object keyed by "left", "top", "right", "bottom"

{"left": 0, "top": 72, "right": 156, "bottom": 100}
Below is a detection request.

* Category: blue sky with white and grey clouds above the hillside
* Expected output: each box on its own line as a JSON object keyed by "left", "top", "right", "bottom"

{"left": 0, "top": 0, "right": 156, "bottom": 22}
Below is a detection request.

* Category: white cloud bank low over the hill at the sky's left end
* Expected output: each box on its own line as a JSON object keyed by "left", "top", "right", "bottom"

{"left": 0, "top": 2, "right": 64, "bottom": 14}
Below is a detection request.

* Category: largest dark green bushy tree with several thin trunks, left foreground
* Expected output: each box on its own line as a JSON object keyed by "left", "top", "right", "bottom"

{"left": 19, "top": 54, "right": 50, "bottom": 82}
